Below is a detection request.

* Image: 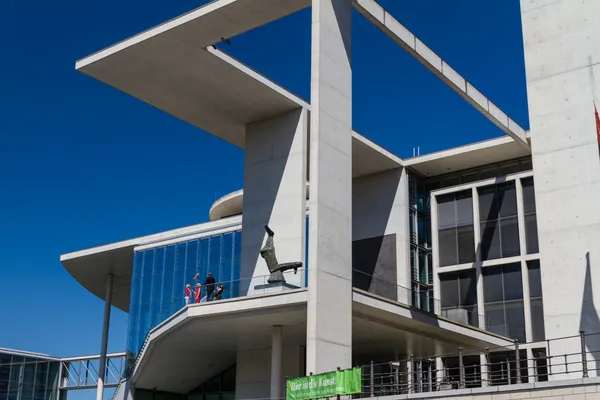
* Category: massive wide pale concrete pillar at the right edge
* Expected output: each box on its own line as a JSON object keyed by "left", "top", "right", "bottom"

{"left": 521, "top": 0, "right": 600, "bottom": 379}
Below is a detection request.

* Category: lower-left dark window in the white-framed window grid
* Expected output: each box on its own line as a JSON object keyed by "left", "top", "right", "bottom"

{"left": 440, "top": 270, "right": 479, "bottom": 326}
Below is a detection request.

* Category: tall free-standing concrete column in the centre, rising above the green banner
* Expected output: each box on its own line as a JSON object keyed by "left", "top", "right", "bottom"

{"left": 306, "top": 0, "right": 352, "bottom": 373}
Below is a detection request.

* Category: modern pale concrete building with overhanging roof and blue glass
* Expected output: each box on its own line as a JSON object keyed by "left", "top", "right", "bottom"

{"left": 54, "top": 0, "right": 600, "bottom": 400}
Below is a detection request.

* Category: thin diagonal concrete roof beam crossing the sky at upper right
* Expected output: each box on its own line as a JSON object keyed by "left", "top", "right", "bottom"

{"left": 352, "top": 0, "right": 531, "bottom": 151}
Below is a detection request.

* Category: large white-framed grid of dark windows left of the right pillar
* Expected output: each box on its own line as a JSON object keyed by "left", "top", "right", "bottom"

{"left": 436, "top": 167, "right": 545, "bottom": 342}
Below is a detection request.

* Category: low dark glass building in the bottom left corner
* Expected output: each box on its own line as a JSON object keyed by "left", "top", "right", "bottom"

{"left": 0, "top": 352, "right": 60, "bottom": 400}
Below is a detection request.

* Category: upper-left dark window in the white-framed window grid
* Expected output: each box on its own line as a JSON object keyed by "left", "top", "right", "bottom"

{"left": 437, "top": 190, "right": 475, "bottom": 267}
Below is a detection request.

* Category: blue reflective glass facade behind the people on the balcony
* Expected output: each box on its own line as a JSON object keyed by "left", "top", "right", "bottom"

{"left": 127, "top": 230, "right": 242, "bottom": 359}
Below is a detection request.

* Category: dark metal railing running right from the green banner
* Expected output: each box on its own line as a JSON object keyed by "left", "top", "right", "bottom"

{"left": 298, "top": 332, "right": 600, "bottom": 398}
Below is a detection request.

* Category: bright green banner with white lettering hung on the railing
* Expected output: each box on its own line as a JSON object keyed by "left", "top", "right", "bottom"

{"left": 285, "top": 368, "right": 362, "bottom": 400}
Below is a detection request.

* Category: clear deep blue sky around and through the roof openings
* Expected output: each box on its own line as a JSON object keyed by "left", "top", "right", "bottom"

{"left": 0, "top": 0, "right": 529, "bottom": 384}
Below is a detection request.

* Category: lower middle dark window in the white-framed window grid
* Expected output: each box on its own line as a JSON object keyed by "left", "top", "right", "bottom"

{"left": 482, "top": 263, "right": 525, "bottom": 342}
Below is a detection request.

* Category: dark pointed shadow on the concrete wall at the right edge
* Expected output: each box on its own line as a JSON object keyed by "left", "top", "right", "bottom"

{"left": 579, "top": 251, "right": 600, "bottom": 372}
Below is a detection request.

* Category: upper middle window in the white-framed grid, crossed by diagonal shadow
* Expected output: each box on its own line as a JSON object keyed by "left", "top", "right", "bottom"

{"left": 478, "top": 182, "right": 521, "bottom": 260}
